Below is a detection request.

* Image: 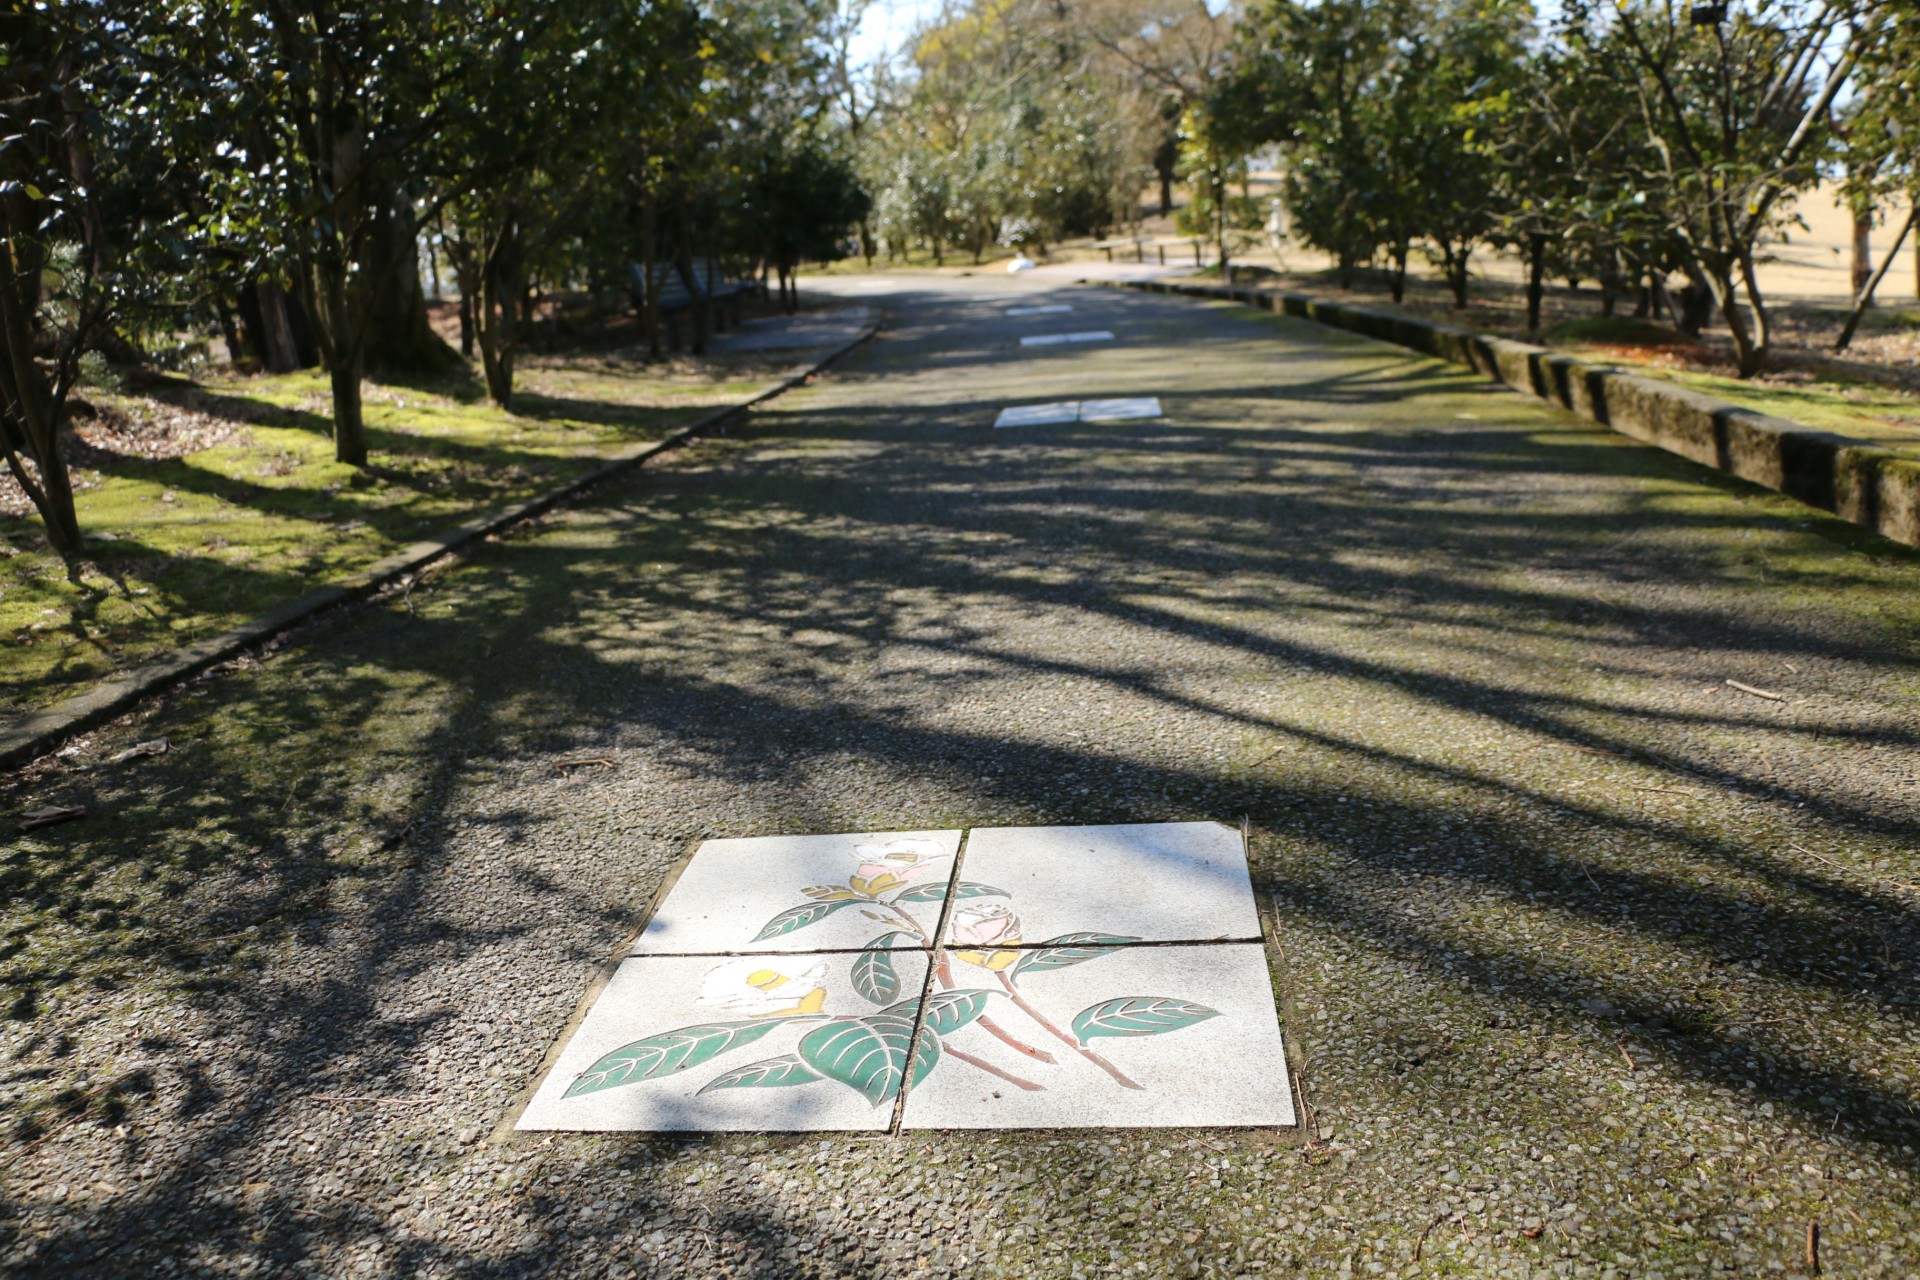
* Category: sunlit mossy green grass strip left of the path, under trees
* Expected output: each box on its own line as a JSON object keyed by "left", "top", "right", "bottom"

{"left": 0, "top": 357, "right": 794, "bottom": 714}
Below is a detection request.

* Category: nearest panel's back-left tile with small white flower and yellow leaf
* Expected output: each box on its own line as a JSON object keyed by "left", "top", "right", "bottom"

{"left": 634, "top": 831, "right": 960, "bottom": 956}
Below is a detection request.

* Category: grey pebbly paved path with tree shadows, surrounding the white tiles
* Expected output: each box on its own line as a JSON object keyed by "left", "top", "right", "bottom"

{"left": 0, "top": 276, "right": 1920, "bottom": 1280}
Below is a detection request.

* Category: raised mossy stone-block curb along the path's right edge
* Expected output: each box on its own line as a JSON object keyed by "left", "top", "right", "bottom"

{"left": 1117, "top": 280, "right": 1920, "bottom": 547}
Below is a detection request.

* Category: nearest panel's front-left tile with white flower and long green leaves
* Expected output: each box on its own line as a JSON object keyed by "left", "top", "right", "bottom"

{"left": 516, "top": 952, "right": 927, "bottom": 1132}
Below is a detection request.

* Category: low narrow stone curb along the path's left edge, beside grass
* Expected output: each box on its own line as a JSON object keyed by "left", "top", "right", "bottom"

{"left": 0, "top": 319, "right": 879, "bottom": 770}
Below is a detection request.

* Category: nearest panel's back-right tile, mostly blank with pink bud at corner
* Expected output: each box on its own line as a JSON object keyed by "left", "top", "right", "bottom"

{"left": 945, "top": 821, "right": 1260, "bottom": 946}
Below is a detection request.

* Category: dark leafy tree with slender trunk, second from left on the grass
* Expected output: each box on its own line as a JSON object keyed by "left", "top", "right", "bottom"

{"left": 127, "top": 0, "right": 495, "bottom": 466}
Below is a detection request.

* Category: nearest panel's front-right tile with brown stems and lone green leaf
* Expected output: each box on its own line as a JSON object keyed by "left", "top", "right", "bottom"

{"left": 902, "top": 942, "right": 1294, "bottom": 1128}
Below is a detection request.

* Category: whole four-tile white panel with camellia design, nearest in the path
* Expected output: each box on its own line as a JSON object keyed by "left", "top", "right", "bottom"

{"left": 518, "top": 823, "right": 1294, "bottom": 1130}
